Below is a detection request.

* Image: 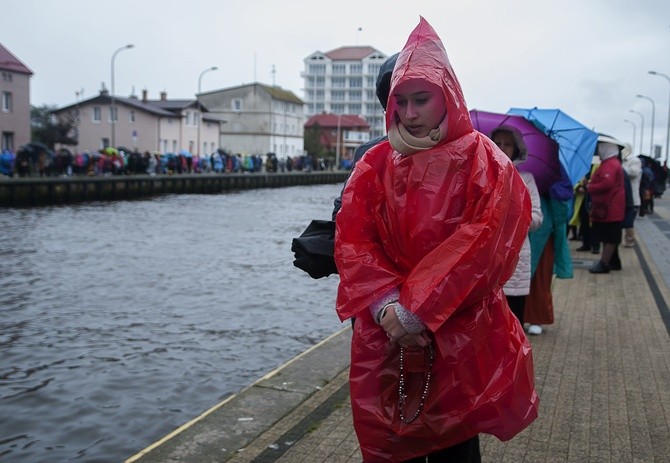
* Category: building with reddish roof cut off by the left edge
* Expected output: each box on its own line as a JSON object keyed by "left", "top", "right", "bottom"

{"left": 0, "top": 44, "right": 33, "bottom": 151}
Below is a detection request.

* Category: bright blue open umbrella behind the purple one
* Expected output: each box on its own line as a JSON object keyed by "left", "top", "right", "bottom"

{"left": 507, "top": 108, "right": 598, "bottom": 185}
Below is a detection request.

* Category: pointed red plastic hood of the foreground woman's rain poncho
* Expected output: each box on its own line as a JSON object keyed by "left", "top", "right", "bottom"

{"left": 386, "top": 17, "right": 474, "bottom": 143}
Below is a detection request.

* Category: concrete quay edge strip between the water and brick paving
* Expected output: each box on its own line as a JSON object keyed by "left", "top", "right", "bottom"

{"left": 125, "top": 327, "right": 351, "bottom": 463}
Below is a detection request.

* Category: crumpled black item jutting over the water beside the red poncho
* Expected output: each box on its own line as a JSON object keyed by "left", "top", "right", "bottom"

{"left": 291, "top": 220, "right": 337, "bottom": 279}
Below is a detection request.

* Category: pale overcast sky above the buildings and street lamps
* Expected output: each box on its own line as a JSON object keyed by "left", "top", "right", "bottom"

{"left": 5, "top": 0, "right": 670, "bottom": 156}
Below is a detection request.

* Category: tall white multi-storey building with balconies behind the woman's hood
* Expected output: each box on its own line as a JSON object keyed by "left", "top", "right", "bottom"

{"left": 302, "top": 46, "right": 388, "bottom": 137}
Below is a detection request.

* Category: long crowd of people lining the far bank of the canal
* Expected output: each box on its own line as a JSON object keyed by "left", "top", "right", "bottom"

{"left": 0, "top": 146, "right": 334, "bottom": 177}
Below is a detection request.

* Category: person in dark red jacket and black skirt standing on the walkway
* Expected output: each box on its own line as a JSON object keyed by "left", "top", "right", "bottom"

{"left": 586, "top": 141, "right": 626, "bottom": 273}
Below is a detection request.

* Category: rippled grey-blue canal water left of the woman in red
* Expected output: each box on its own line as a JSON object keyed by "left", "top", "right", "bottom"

{"left": 0, "top": 185, "right": 343, "bottom": 463}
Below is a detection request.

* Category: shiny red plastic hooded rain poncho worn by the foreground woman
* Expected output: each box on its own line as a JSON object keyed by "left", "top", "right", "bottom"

{"left": 335, "top": 18, "right": 539, "bottom": 462}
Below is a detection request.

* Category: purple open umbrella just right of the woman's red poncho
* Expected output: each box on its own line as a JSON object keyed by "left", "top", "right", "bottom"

{"left": 470, "top": 109, "right": 561, "bottom": 194}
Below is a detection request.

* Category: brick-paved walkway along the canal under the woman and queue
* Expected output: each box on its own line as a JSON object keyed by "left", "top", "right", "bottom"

{"left": 130, "top": 200, "right": 670, "bottom": 463}
